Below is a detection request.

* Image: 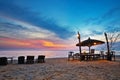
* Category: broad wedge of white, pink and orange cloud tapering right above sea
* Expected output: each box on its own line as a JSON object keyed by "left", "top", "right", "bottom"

{"left": 0, "top": 20, "right": 75, "bottom": 50}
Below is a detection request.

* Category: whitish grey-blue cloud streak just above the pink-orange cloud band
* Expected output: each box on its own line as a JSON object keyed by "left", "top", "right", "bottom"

{"left": 0, "top": 23, "right": 58, "bottom": 40}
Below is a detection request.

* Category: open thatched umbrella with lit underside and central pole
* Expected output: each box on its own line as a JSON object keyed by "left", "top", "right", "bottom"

{"left": 76, "top": 38, "right": 105, "bottom": 53}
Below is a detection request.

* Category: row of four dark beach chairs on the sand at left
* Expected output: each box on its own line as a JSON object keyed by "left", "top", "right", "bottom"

{"left": 0, "top": 55, "right": 45, "bottom": 65}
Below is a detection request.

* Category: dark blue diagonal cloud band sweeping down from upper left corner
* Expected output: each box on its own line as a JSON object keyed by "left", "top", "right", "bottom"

{"left": 0, "top": 1, "right": 74, "bottom": 39}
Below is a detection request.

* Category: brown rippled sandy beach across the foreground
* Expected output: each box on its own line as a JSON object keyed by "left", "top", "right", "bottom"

{"left": 0, "top": 58, "right": 120, "bottom": 80}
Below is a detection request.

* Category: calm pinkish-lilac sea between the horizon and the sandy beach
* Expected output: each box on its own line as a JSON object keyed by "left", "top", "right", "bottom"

{"left": 0, "top": 50, "right": 120, "bottom": 59}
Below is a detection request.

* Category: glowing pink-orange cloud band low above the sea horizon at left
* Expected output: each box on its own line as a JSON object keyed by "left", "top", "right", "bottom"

{"left": 0, "top": 38, "right": 76, "bottom": 50}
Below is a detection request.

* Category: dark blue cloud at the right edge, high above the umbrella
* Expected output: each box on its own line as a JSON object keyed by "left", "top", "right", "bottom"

{"left": 85, "top": 7, "right": 120, "bottom": 24}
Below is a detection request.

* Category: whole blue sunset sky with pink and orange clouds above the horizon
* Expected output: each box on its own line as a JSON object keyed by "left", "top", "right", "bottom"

{"left": 0, "top": 0, "right": 120, "bottom": 50}
